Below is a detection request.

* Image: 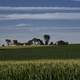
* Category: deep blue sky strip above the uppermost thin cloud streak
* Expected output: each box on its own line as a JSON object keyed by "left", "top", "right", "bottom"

{"left": 0, "top": 0, "right": 80, "bottom": 7}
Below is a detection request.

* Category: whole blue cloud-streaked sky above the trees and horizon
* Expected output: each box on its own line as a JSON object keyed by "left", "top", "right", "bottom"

{"left": 0, "top": 0, "right": 80, "bottom": 43}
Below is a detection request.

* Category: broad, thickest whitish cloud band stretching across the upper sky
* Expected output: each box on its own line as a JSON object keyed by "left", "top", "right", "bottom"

{"left": 0, "top": 13, "right": 80, "bottom": 20}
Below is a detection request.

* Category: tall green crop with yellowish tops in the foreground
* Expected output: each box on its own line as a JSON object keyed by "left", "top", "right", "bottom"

{"left": 0, "top": 60, "right": 80, "bottom": 80}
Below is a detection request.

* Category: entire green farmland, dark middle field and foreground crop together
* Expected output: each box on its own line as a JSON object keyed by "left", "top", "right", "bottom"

{"left": 0, "top": 45, "right": 80, "bottom": 80}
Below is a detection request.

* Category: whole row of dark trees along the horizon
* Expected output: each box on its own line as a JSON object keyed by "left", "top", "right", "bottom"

{"left": 2, "top": 34, "right": 69, "bottom": 46}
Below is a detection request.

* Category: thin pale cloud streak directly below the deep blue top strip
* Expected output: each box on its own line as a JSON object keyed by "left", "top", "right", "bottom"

{"left": 0, "top": 6, "right": 80, "bottom": 10}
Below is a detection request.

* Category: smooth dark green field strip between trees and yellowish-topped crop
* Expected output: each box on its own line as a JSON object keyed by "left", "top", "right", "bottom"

{"left": 0, "top": 45, "right": 80, "bottom": 60}
